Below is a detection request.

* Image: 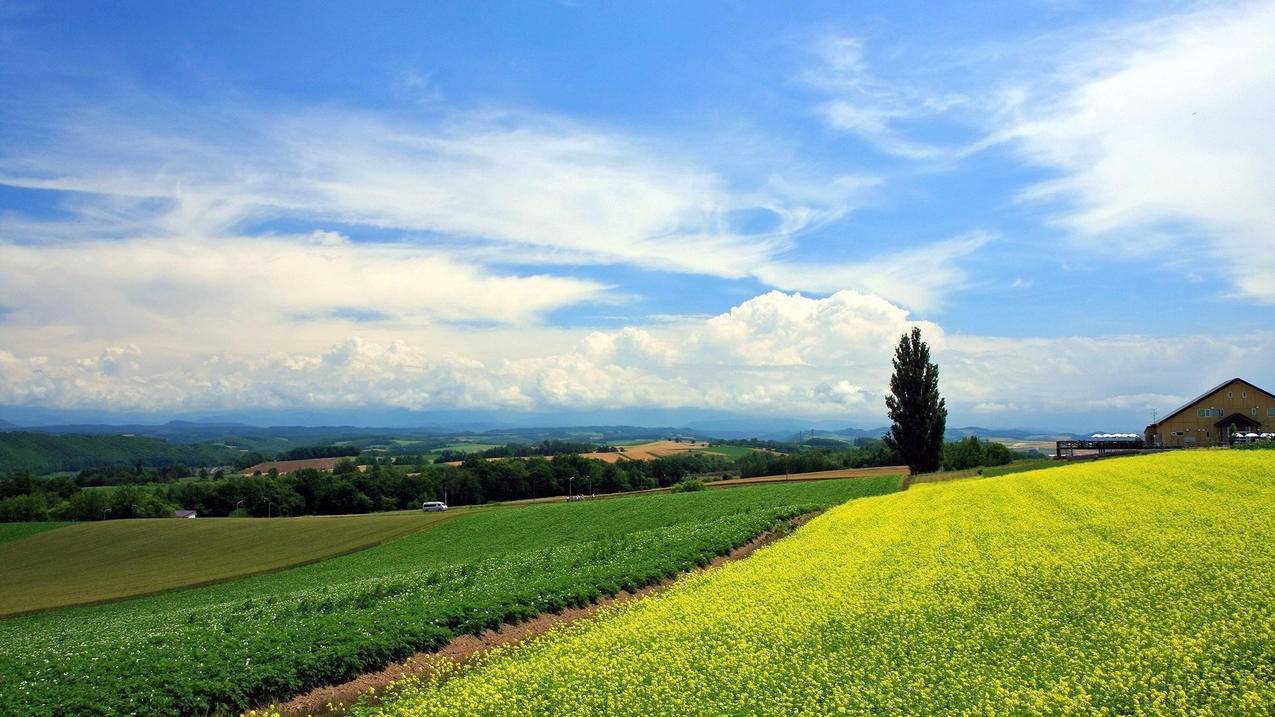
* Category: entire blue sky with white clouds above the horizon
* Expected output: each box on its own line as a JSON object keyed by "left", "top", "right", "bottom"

{"left": 0, "top": 0, "right": 1275, "bottom": 430}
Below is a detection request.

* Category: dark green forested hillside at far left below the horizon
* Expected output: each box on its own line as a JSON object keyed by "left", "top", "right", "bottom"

{"left": 0, "top": 432, "right": 240, "bottom": 475}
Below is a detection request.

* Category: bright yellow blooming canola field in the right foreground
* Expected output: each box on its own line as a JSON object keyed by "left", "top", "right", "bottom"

{"left": 356, "top": 452, "right": 1275, "bottom": 717}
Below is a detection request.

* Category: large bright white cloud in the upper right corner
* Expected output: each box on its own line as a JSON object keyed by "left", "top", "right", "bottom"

{"left": 1003, "top": 3, "right": 1275, "bottom": 304}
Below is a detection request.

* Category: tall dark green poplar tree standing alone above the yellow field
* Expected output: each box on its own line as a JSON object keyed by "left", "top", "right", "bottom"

{"left": 884, "top": 327, "right": 947, "bottom": 473}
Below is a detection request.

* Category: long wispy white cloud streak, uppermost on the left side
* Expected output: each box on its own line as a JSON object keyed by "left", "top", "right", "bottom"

{"left": 0, "top": 103, "right": 870, "bottom": 278}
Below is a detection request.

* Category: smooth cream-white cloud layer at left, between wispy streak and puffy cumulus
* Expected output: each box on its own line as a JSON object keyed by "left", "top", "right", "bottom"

{"left": 0, "top": 232, "right": 604, "bottom": 339}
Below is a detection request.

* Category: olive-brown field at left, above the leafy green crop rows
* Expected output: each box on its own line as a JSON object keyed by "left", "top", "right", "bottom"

{"left": 0, "top": 512, "right": 458, "bottom": 616}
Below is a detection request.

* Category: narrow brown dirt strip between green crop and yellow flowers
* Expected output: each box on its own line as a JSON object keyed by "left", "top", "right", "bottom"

{"left": 261, "top": 513, "right": 817, "bottom": 717}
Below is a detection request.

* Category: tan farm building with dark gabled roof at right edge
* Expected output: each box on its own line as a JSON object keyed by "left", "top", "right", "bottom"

{"left": 1146, "top": 379, "right": 1275, "bottom": 448}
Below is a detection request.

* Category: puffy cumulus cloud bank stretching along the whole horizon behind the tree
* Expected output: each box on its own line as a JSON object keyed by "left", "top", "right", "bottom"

{"left": 0, "top": 291, "right": 1275, "bottom": 425}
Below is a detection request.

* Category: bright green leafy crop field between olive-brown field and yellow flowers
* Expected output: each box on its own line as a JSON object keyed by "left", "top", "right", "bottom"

{"left": 0, "top": 476, "right": 899, "bottom": 716}
